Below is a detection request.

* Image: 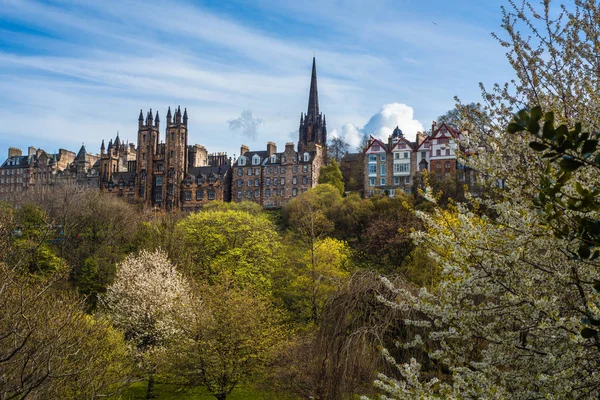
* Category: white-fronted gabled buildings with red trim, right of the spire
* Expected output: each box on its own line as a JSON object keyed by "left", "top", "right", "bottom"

{"left": 364, "top": 122, "right": 475, "bottom": 198}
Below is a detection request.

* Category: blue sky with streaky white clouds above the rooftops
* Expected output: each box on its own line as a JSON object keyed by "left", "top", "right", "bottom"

{"left": 0, "top": 0, "right": 512, "bottom": 162}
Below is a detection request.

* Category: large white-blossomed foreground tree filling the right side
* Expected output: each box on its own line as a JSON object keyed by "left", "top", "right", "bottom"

{"left": 366, "top": 0, "right": 600, "bottom": 399}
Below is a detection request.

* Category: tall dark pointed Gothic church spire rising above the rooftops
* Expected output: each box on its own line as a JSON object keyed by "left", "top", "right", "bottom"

{"left": 298, "top": 57, "right": 327, "bottom": 154}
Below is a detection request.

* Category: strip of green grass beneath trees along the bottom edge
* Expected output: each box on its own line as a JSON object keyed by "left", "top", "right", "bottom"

{"left": 121, "top": 382, "right": 296, "bottom": 400}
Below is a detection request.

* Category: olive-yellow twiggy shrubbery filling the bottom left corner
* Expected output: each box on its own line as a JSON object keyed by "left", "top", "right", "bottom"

{"left": 0, "top": 263, "right": 131, "bottom": 399}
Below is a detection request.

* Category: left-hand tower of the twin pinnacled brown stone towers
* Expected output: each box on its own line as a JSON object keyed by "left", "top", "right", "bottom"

{"left": 135, "top": 109, "right": 160, "bottom": 206}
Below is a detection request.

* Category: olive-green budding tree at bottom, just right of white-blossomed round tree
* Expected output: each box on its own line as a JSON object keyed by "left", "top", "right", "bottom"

{"left": 170, "top": 285, "right": 283, "bottom": 400}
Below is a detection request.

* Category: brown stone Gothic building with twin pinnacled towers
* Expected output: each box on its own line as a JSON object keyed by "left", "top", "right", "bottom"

{"left": 100, "top": 107, "right": 231, "bottom": 210}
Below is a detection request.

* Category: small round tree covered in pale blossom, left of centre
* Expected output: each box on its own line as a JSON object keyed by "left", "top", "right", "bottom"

{"left": 100, "top": 250, "right": 190, "bottom": 398}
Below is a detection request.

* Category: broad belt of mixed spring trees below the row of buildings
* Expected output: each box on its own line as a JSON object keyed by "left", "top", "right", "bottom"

{"left": 0, "top": 184, "right": 439, "bottom": 399}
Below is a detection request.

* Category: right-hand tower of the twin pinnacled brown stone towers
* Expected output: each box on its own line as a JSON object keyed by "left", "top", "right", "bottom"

{"left": 165, "top": 107, "right": 188, "bottom": 210}
